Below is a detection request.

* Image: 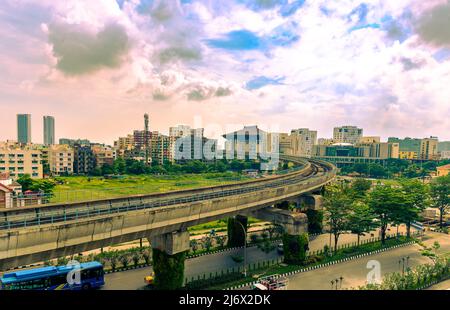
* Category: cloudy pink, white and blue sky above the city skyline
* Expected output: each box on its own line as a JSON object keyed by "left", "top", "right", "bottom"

{"left": 0, "top": 0, "right": 450, "bottom": 143}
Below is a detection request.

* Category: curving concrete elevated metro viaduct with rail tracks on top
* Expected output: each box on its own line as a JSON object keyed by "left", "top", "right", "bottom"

{"left": 0, "top": 156, "right": 336, "bottom": 286}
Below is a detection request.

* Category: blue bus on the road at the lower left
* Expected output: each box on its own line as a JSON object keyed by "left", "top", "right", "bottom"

{"left": 0, "top": 262, "right": 105, "bottom": 290}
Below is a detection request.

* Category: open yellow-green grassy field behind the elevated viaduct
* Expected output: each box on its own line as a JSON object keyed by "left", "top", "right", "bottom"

{"left": 51, "top": 173, "right": 253, "bottom": 202}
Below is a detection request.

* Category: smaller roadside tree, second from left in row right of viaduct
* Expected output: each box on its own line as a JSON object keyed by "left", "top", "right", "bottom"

{"left": 349, "top": 202, "right": 376, "bottom": 246}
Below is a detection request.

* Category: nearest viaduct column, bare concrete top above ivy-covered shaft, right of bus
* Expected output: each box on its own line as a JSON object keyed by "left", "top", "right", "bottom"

{"left": 150, "top": 231, "right": 189, "bottom": 290}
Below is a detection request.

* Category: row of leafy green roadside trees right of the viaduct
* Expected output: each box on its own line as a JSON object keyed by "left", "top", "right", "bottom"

{"left": 324, "top": 175, "right": 450, "bottom": 250}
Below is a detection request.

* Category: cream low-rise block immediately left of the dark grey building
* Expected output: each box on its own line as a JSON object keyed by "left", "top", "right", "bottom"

{"left": 48, "top": 145, "right": 75, "bottom": 175}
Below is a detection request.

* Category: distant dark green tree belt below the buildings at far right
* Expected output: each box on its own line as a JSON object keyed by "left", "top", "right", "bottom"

{"left": 341, "top": 159, "right": 450, "bottom": 178}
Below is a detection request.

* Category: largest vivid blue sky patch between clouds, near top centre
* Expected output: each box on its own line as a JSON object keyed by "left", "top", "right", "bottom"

{"left": 206, "top": 30, "right": 261, "bottom": 50}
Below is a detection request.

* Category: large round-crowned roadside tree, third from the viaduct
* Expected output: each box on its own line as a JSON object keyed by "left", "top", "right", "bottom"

{"left": 368, "top": 185, "right": 406, "bottom": 245}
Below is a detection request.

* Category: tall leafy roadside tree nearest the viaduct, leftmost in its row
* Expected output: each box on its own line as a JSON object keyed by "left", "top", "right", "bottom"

{"left": 324, "top": 184, "right": 352, "bottom": 252}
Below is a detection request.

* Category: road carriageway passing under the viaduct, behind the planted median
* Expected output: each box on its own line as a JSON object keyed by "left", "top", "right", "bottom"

{"left": 103, "top": 227, "right": 414, "bottom": 290}
